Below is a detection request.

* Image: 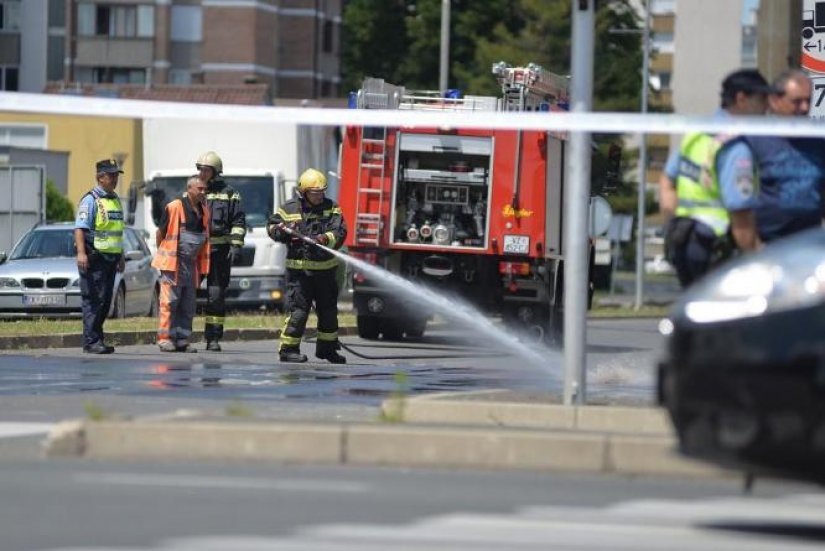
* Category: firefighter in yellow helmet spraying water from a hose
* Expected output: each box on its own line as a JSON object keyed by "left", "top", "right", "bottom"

{"left": 267, "top": 168, "right": 347, "bottom": 364}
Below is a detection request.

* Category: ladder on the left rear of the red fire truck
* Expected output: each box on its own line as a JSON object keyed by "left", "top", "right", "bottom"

{"left": 355, "top": 78, "right": 404, "bottom": 246}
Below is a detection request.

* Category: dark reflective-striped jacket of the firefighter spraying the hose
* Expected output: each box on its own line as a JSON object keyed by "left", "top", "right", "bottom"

{"left": 266, "top": 197, "right": 347, "bottom": 271}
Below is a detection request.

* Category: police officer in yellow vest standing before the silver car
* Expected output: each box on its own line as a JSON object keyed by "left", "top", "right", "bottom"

{"left": 74, "top": 159, "right": 126, "bottom": 354}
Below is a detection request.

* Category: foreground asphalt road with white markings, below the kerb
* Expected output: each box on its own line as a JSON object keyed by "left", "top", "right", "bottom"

{"left": 0, "top": 461, "right": 825, "bottom": 551}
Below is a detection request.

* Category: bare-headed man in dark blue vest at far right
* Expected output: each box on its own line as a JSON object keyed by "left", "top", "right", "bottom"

{"left": 747, "top": 69, "right": 825, "bottom": 243}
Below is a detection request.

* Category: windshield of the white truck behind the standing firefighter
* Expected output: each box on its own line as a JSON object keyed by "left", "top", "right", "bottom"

{"left": 152, "top": 175, "right": 275, "bottom": 228}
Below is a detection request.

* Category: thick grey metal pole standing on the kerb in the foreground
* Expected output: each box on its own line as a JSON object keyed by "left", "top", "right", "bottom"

{"left": 564, "top": 0, "right": 594, "bottom": 405}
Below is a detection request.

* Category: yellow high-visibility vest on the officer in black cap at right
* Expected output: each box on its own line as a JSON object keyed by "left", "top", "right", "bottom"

{"left": 676, "top": 132, "right": 730, "bottom": 236}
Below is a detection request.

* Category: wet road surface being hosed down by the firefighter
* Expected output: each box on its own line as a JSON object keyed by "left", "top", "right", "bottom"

{"left": 0, "top": 320, "right": 660, "bottom": 421}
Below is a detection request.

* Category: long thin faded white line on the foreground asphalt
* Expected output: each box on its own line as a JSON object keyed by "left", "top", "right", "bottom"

{"left": 74, "top": 473, "right": 370, "bottom": 494}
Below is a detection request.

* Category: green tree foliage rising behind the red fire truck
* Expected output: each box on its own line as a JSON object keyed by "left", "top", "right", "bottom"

{"left": 342, "top": 0, "right": 642, "bottom": 111}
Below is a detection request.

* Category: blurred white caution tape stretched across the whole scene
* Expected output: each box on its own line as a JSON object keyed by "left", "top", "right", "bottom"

{"left": 0, "top": 92, "right": 825, "bottom": 137}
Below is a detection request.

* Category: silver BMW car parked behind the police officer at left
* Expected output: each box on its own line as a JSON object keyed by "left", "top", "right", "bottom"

{"left": 0, "top": 222, "right": 159, "bottom": 318}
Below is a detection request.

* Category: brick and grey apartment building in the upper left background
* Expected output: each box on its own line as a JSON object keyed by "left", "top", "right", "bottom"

{"left": 0, "top": 0, "right": 343, "bottom": 99}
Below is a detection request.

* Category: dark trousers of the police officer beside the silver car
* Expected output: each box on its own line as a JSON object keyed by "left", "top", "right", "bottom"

{"left": 80, "top": 254, "right": 117, "bottom": 348}
